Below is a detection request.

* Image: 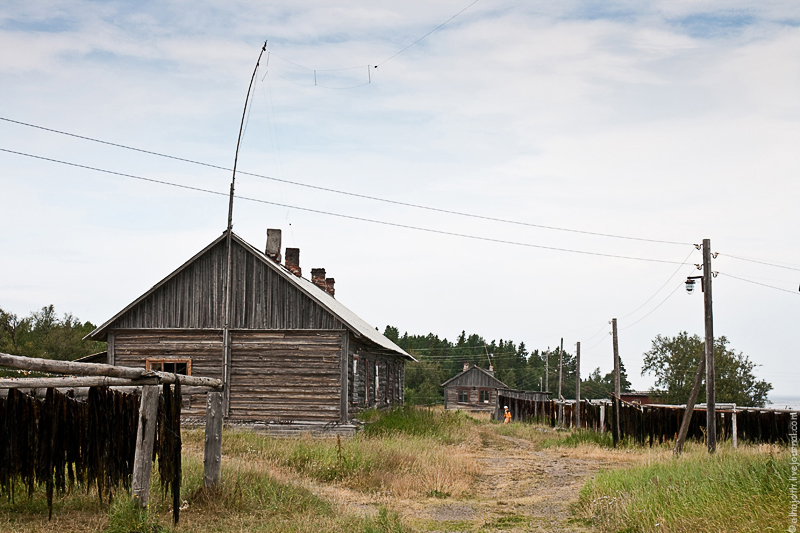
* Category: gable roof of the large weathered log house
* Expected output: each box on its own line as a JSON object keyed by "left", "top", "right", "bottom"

{"left": 86, "top": 233, "right": 416, "bottom": 361}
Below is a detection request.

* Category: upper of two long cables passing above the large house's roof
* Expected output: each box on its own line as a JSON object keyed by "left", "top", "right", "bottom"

{"left": 0, "top": 115, "right": 692, "bottom": 246}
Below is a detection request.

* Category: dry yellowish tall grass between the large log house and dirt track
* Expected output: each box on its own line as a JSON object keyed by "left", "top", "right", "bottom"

{"left": 206, "top": 408, "right": 478, "bottom": 497}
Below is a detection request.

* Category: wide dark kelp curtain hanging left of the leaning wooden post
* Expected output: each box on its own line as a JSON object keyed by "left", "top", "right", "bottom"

{"left": 0, "top": 387, "right": 139, "bottom": 517}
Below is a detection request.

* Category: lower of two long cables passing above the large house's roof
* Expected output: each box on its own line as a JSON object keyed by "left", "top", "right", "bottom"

{"left": 0, "top": 148, "right": 685, "bottom": 265}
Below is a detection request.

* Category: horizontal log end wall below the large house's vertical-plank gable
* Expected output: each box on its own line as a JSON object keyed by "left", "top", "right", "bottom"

{"left": 113, "top": 330, "right": 347, "bottom": 423}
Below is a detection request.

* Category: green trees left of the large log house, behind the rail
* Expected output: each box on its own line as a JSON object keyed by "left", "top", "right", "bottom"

{"left": 0, "top": 305, "right": 106, "bottom": 361}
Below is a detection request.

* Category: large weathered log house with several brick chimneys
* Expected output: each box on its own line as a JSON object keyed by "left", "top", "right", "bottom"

{"left": 87, "top": 230, "right": 414, "bottom": 427}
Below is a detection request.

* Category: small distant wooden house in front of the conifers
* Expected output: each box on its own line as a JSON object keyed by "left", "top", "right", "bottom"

{"left": 442, "top": 363, "right": 508, "bottom": 413}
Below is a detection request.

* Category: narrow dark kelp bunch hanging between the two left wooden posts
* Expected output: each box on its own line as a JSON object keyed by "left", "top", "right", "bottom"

{"left": 154, "top": 381, "right": 181, "bottom": 524}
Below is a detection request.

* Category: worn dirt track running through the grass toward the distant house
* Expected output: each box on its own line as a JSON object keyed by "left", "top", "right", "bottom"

{"left": 310, "top": 430, "right": 636, "bottom": 533}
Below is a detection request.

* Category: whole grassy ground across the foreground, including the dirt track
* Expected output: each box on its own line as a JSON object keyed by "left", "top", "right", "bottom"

{"left": 0, "top": 408, "right": 791, "bottom": 533}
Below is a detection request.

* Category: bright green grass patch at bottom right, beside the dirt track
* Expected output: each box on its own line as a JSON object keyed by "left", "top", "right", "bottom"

{"left": 575, "top": 447, "right": 791, "bottom": 533}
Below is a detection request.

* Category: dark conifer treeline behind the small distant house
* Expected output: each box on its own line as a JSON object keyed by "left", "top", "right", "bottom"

{"left": 384, "top": 326, "right": 630, "bottom": 405}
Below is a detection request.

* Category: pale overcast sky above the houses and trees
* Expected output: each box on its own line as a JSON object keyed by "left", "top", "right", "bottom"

{"left": 0, "top": 0, "right": 800, "bottom": 396}
